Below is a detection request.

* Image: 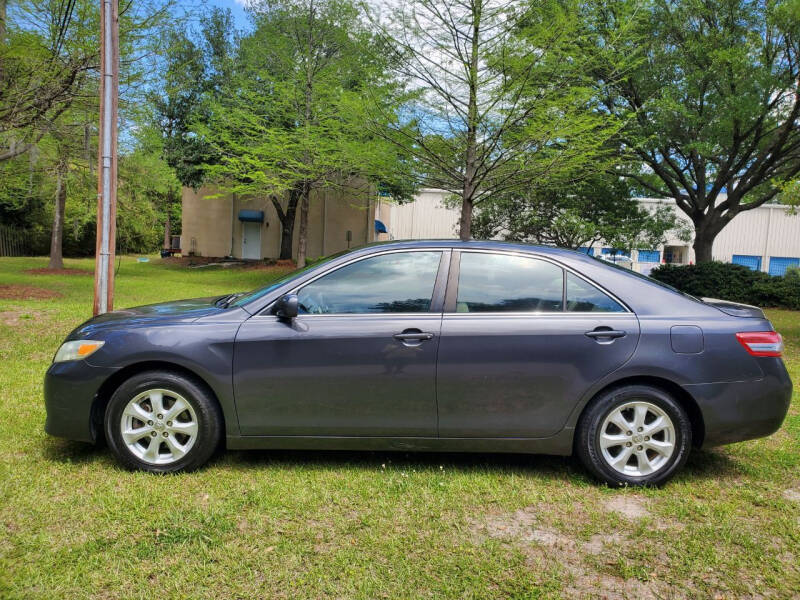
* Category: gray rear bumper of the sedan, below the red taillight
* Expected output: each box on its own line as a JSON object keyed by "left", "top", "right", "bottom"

{"left": 685, "top": 358, "right": 792, "bottom": 447}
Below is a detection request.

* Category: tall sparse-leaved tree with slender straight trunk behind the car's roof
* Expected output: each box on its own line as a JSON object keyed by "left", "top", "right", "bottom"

{"left": 372, "top": 0, "right": 616, "bottom": 239}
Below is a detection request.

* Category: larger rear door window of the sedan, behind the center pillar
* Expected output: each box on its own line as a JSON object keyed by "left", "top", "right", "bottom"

{"left": 456, "top": 252, "right": 564, "bottom": 312}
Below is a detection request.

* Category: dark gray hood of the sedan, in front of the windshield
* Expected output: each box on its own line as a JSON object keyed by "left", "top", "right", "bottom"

{"left": 67, "top": 296, "right": 227, "bottom": 339}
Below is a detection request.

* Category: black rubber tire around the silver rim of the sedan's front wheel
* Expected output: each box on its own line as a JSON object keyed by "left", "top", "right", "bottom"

{"left": 104, "top": 371, "right": 223, "bottom": 473}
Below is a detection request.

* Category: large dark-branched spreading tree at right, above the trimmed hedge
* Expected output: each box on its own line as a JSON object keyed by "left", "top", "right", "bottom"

{"left": 586, "top": 0, "right": 800, "bottom": 262}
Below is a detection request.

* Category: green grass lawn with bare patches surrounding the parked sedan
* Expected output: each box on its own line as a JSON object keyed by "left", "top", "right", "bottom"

{"left": 0, "top": 258, "right": 800, "bottom": 600}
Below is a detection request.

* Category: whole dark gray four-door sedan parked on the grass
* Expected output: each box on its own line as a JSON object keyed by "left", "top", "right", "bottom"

{"left": 45, "top": 241, "right": 792, "bottom": 485}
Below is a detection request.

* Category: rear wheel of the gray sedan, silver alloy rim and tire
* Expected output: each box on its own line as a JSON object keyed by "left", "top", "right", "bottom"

{"left": 575, "top": 385, "right": 692, "bottom": 486}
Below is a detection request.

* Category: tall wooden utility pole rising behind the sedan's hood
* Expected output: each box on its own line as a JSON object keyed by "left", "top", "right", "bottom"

{"left": 94, "top": 0, "right": 119, "bottom": 315}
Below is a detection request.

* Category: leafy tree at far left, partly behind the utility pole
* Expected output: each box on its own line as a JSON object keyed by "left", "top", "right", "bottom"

{"left": 0, "top": 0, "right": 177, "bottom": 268}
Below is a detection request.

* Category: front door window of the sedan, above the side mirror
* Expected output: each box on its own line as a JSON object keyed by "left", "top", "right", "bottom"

{"left": 298, "top": 252, "right": 442, "bottom": 315}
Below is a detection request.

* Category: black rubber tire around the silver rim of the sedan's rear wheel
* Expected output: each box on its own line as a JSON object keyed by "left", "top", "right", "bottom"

{"left": 575, "top": 385, "right": 692, "bottom": 486}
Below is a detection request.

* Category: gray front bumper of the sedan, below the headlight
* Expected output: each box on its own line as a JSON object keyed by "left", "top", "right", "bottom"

{"left": 44, "top": 360, "right": 117, "bottom": 443}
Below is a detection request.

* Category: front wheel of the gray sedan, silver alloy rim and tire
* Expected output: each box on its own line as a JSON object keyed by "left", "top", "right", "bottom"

{"left": 105, "top": 371, "right": 222, "bottom": 473}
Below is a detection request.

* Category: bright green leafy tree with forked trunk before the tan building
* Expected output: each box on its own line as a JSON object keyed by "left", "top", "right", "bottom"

{"left": 195, "top": 0, "right": 412, "bottom": 266}
